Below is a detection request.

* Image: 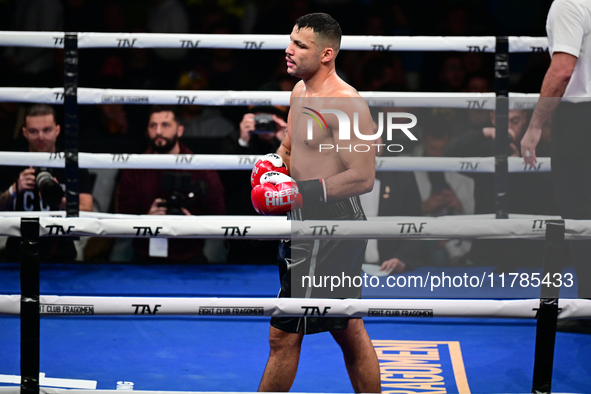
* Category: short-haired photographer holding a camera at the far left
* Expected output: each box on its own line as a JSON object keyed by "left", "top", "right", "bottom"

{"left": 0, "top": 104, "right": 93, "bottom": 263}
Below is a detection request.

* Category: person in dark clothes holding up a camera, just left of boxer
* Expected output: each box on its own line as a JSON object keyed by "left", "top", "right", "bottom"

{"left": 221, "top": 106, "right": 288, "bottom": 264}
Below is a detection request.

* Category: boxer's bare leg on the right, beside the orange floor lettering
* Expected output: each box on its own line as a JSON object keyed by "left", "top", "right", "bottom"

{"left": 330, "top": 319, "right": 382, "bottom": 393}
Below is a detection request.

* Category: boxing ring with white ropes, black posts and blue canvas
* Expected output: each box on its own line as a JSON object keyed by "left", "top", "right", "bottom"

{"left": 0, "top": 32, "right": 591, "bottom": 394}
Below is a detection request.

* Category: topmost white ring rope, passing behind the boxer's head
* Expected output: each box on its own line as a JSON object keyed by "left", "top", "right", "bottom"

{"left": 0, "top": 31, "right": 548, "bottom": 53}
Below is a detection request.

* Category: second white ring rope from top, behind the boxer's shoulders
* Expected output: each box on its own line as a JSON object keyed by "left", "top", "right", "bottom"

{"left": 0, "top": 88, "right": 544, "bottom": 110}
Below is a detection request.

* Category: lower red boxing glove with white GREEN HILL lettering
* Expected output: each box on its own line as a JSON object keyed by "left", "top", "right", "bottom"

{"left": 250, "top": 172, "right": 302, "bottom": 215}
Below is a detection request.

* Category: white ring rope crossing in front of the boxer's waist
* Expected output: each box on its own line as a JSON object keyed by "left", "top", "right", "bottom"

{"left": 0, "top": 215, "right": 591, "bottom": 240}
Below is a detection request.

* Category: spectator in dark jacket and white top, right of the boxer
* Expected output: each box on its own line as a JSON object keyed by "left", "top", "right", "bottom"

{"left": 413, "top": 117, "right": 474, "bottom": 266}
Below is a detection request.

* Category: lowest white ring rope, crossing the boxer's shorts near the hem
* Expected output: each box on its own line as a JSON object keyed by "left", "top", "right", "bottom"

{"left": 0, "top": 294, "right": 591, "bottom": 319}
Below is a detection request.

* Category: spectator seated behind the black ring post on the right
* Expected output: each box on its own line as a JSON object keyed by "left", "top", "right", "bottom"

{"left": 445, "top": 110, "right": 555, "bottom": 267}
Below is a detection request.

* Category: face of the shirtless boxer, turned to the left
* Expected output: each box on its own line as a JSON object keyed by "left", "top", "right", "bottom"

{"left": 285, "top": 26, "right": 320, "bottom": 78}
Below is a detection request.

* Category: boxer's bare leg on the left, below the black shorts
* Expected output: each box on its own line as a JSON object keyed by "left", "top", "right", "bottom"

{"left": 259, "top": 326, "right": 304, "bottom": 392}
